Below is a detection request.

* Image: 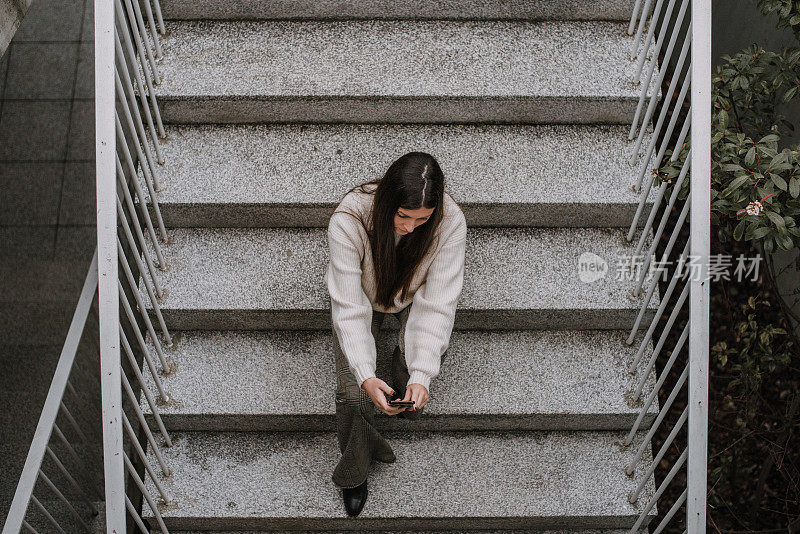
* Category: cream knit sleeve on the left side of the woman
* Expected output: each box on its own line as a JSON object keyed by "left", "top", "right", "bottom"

{"left": 325, "top": 213, "right": 376, "bottom": 387}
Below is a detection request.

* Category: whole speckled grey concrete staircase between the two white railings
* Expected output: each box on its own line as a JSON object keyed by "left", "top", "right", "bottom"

{"left": 143, "top": 0, "right": 658, "bottom": 534}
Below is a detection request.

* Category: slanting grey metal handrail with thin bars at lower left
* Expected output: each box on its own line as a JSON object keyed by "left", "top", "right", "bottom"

{"left": 3, "top": 249, "right": 99, "bottom": 534}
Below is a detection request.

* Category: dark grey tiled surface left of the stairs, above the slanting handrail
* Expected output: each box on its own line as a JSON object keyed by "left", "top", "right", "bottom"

{"left": 0, "top": 0, "right": 97, "bottom": 524}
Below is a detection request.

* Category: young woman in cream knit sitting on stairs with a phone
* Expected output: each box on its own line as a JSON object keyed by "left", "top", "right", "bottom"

{"left": 325, "top": 152, "right": 467, "bottom": 516}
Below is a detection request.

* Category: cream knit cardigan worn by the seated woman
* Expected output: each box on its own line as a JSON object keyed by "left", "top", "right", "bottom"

{"left": 325, "top": 186, "right": 467, "bottom": 391}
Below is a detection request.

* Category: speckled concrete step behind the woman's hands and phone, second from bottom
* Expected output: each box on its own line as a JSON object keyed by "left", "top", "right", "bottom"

{"left": 142, "top": 331, "right": 657, "bottom": 431}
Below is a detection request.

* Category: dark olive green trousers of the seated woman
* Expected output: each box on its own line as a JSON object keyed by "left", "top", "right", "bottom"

{"left": 331, "top": 304, "right": 446, "bottom": 488}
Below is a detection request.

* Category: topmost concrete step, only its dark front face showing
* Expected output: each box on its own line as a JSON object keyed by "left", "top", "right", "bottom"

{"left": 161, "top": 0, "right": 633, "bottom": 21}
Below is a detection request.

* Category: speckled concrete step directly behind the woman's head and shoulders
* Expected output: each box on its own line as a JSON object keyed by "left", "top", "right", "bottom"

{"left": 143, "top": 124, "right": 652, "bottom": 228}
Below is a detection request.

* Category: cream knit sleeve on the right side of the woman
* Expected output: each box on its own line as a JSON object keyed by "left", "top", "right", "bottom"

{"left": 403, "top": 211, "right": 467, "bottom": 390}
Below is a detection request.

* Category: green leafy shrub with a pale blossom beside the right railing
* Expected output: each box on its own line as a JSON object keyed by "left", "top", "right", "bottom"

{"left": 657, "top": 45, "right": 800, "bottom": 258}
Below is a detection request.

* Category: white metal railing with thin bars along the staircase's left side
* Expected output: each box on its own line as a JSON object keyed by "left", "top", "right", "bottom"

{"left": 95, "top": 0, "right": 174, "bottom": 534}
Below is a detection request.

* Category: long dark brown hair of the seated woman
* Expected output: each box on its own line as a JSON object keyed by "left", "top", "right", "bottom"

{"left": 334, "top": 152, "right": 444, "bottom": 308}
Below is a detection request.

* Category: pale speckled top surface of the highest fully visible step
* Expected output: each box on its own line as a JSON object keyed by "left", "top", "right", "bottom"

{"left": 156, "top": 20, "right": 656, "bottom": 100}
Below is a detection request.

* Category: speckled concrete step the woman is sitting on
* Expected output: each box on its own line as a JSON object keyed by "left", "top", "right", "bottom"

{"left": 140, "top": 228, "right": 657, "bottom": 330}
